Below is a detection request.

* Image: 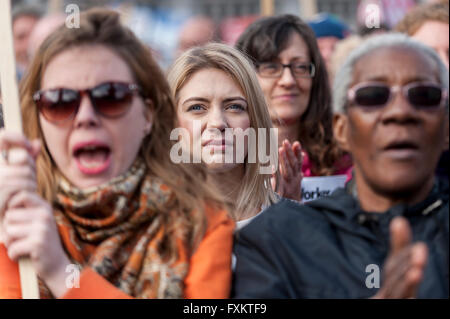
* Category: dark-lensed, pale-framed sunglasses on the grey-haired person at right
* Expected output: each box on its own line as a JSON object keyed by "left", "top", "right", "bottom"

{"left": 347, "top": 82, "right": 447, "bottom": 109}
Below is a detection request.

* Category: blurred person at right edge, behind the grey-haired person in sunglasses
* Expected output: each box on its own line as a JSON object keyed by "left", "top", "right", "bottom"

{"left": 396, "top": 0, "right": 450, "bottom": 178}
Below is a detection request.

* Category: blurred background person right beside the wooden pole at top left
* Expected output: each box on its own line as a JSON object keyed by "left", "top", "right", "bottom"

{"left": 12, "top": 5, "right": 42, "bottom": 79}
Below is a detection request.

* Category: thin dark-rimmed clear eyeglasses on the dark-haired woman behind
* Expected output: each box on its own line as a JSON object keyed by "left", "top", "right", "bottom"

{"left": 257, "top": 62, "right": 316, "bottom": 78}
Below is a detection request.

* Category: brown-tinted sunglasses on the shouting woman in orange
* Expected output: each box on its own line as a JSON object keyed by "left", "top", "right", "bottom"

{"left": 33, "top": 82, "right": 141, "bottom": 123}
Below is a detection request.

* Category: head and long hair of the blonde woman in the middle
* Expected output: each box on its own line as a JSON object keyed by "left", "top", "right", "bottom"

{"left": 168, "top": 43, "right": 277, "bottom": 227}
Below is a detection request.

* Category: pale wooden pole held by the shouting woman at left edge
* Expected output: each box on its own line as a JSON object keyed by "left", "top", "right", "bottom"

{"left": 0, "top": 0, "right": 39, "bottom": 299}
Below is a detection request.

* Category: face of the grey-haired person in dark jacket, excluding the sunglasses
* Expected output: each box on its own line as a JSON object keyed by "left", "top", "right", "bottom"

{"left": 335, "top": 48, "right": 449, "bottom": 198}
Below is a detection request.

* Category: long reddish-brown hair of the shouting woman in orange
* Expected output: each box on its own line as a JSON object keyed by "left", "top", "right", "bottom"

{"left": 21, "top": 9, "right": 221, "bottom": 257}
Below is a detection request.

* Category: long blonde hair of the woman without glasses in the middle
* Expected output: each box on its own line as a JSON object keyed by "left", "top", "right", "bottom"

{"left": 168, "top": 43, "right": 278, "bottom": 220}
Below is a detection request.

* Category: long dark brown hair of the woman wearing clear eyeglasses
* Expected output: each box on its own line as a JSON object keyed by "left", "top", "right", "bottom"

{"left": 236, "top": 14, "right": 341, "bottom": 175}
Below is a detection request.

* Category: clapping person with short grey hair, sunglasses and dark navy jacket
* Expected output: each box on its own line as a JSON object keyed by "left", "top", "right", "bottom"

{"left": 233, "top": 34, "right": 449, "bottom": 298}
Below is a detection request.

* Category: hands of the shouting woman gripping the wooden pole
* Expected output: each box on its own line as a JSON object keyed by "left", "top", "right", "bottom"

{"left": 0, "top": 130, "right": 70, "bottom": 297}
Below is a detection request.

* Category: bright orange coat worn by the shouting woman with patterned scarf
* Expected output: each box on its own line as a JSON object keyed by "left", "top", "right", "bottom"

{"left": 0, "top": 209, "right": 235, "bottom": 299}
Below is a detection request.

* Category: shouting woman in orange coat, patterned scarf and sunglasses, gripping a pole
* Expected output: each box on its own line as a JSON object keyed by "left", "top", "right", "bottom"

{"left": 0, "top": 10, "right": 234, "bottom": 298}
